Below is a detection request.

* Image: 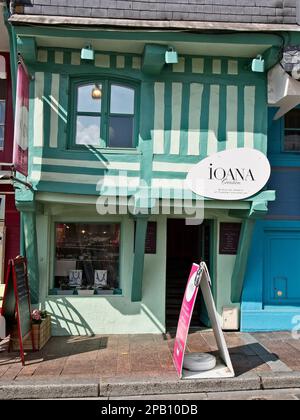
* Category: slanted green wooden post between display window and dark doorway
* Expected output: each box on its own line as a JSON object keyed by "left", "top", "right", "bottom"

{"left": 131, "top": 215, "right": 149, "bottom": 302}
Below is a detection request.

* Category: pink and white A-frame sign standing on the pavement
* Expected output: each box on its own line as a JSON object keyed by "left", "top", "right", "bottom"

{"left": 173, "top": 262, "right": 235, "bottom": 379}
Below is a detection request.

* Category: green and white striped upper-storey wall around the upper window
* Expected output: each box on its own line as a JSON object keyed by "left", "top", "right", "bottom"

{"left": 29, "top": 49, "right": 267, "bottom": 199}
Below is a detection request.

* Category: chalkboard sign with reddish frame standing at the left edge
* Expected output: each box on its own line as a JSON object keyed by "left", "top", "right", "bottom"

{"left": 1, "top": 257, "right": 35, "bottom": 365}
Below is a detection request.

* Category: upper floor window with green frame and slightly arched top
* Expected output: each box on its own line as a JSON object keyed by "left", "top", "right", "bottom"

{"left": 74, "top": 80, "right": 136, "bottom": 148}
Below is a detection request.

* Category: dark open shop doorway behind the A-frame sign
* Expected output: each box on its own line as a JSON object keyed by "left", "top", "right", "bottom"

{"left": 166, "top": 219, "right": 211, "bottom": 331}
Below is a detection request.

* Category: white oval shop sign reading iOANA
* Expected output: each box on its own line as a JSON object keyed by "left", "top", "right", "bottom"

{"left": 185, "top": 148, "right": 271, "bottom": 200}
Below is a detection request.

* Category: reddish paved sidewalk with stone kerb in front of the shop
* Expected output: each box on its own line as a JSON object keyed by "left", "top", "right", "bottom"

{"left": 0, "top": 331, "right": 300, "bottom": 398}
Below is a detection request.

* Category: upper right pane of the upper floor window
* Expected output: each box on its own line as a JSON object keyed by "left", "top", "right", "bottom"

{"left": 110, "top": 85, "right": 134, "bottom": 115}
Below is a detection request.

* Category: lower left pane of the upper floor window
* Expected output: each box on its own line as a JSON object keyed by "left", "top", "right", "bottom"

{"left": 76, "top": 115, "right": 101, "bottom": 146}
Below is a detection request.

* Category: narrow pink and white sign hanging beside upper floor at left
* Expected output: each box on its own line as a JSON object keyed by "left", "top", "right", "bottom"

{"left": 13, "top": 63, "right": 29, "bottom": 176}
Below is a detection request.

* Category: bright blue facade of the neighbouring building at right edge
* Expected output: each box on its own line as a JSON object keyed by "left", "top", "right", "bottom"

{"left": 241, "top": 108, "right": 300, "bottom": 331}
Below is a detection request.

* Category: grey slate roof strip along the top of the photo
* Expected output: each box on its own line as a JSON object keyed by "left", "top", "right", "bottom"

{"left": 15, "top": 0, "right": 300, "bottom": 25}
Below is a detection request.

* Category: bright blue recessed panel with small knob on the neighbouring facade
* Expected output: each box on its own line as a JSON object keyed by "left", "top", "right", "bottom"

{"left": 264, "top": 231, "right": 300, "bottom": 306}
